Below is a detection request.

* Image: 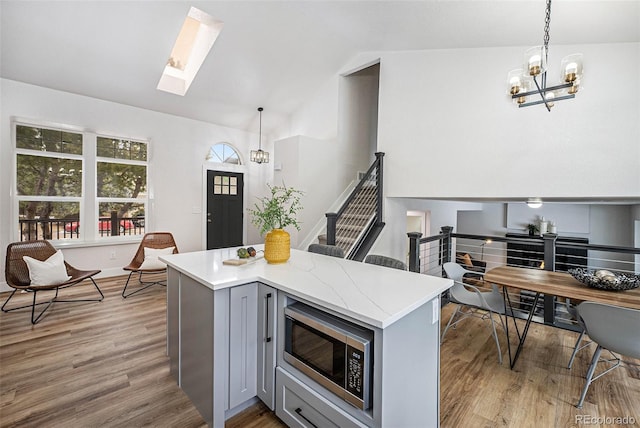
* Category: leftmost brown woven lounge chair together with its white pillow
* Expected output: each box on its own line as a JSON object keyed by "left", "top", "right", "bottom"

{"left": 2, "top": 240, "right": 104, "bottom": 324}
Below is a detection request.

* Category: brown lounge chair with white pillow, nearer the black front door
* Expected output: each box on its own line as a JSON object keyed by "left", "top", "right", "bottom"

{"left": 122, "top": 232, "right": 178, "bottom": 298}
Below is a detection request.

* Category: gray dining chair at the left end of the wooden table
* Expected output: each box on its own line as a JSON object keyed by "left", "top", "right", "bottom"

{"left": 440, "top": 262, "right": 505, "bottom": 364}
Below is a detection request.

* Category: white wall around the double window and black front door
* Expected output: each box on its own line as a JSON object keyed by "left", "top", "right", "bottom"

{"left": 0, "top": 79, "right": 273, "bottom": 290}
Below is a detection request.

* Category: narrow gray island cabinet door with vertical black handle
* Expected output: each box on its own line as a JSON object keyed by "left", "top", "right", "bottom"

{"left": 257, "top": 284, "right": 277, "bottom": 410}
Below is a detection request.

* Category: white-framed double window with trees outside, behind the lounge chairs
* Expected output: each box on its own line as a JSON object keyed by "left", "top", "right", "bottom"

{"left": 15, "top": 123, "right": 148, "bottom": 241}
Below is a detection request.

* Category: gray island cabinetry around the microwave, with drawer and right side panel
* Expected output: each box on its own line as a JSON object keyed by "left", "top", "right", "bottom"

{"left": 275, "top": 290, "right": 440, "bottom": 428}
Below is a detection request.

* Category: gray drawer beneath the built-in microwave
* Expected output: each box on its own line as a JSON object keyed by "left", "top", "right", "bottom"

{"left": 276, "top": 367, "right": 366, "bottom": 428}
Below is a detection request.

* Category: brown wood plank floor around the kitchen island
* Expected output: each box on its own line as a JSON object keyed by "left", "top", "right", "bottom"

{"left": 0, "top": 277, "right": 640, "bottom": 428}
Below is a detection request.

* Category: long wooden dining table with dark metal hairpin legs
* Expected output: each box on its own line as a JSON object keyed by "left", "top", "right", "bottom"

{"left": 484, "top": 266, "right": 640, "bottom": 369}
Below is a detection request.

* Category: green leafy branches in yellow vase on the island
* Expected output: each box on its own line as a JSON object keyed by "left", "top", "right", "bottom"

{"left": 248, "top": 184, "right": 304, "bottom": 264}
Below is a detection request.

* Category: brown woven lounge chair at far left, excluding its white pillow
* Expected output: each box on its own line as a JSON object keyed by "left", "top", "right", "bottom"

{"left": 1, "top": 240, "right": 104, "bottom": 324}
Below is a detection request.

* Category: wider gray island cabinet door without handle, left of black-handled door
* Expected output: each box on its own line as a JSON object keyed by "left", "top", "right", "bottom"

{"left": 229, "top": 283, "right": 258, "bottom": 409}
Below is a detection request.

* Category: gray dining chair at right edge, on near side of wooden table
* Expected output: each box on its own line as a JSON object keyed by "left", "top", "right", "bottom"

{"left": 576, "top": 302, "right": 640, "bottom": 409}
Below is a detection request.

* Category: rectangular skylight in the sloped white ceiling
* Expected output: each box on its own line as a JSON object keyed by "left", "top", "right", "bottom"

{"left": 157, "top": 7, "right": 224, "bottom": 95}
